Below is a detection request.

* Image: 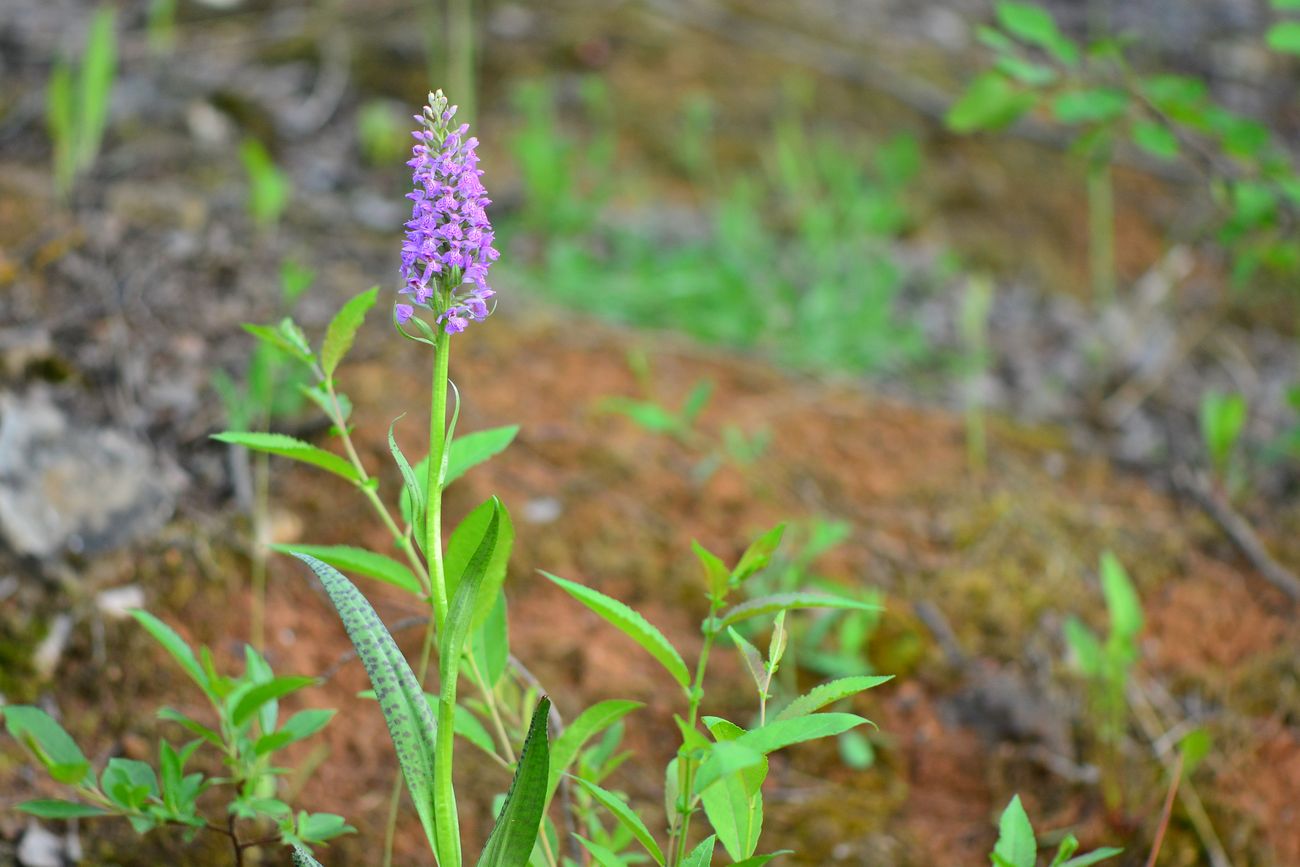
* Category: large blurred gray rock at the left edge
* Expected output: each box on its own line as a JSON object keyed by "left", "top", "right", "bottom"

{"left": 0, "top": 391, "right": 177, "bottom": 558}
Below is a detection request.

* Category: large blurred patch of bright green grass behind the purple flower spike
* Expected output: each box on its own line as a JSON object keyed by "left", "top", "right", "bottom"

{"left": 502, "top": 83, "right": 928, "bottom": 372}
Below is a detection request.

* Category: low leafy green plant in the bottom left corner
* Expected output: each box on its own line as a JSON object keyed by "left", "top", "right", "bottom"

{"left": 0, "top": 611, "right": 355, "bottom": 864}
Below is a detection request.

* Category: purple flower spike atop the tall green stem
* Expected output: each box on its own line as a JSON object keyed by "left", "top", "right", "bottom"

{"left": 394, "top": 90, "right": 501, "bottom": 334}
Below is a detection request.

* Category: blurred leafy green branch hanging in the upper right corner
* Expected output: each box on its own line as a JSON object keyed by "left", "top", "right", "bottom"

{"left": 946, "top": 0, "right": 1300, "bottom": 291}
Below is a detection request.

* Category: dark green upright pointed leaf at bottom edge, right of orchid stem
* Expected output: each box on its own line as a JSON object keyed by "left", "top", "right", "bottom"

{"left": 478, "top": 697, "right": 551, "bottom": 867}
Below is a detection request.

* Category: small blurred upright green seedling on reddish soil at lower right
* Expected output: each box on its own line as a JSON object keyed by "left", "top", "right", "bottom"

{"left": 1065, "top": 551, "right": 1143, "bottom": 809}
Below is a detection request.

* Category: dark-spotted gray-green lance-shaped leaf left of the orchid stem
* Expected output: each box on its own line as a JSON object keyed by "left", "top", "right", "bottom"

{"left": 295, "top": 554, "right": 436, "bottom": 844}
